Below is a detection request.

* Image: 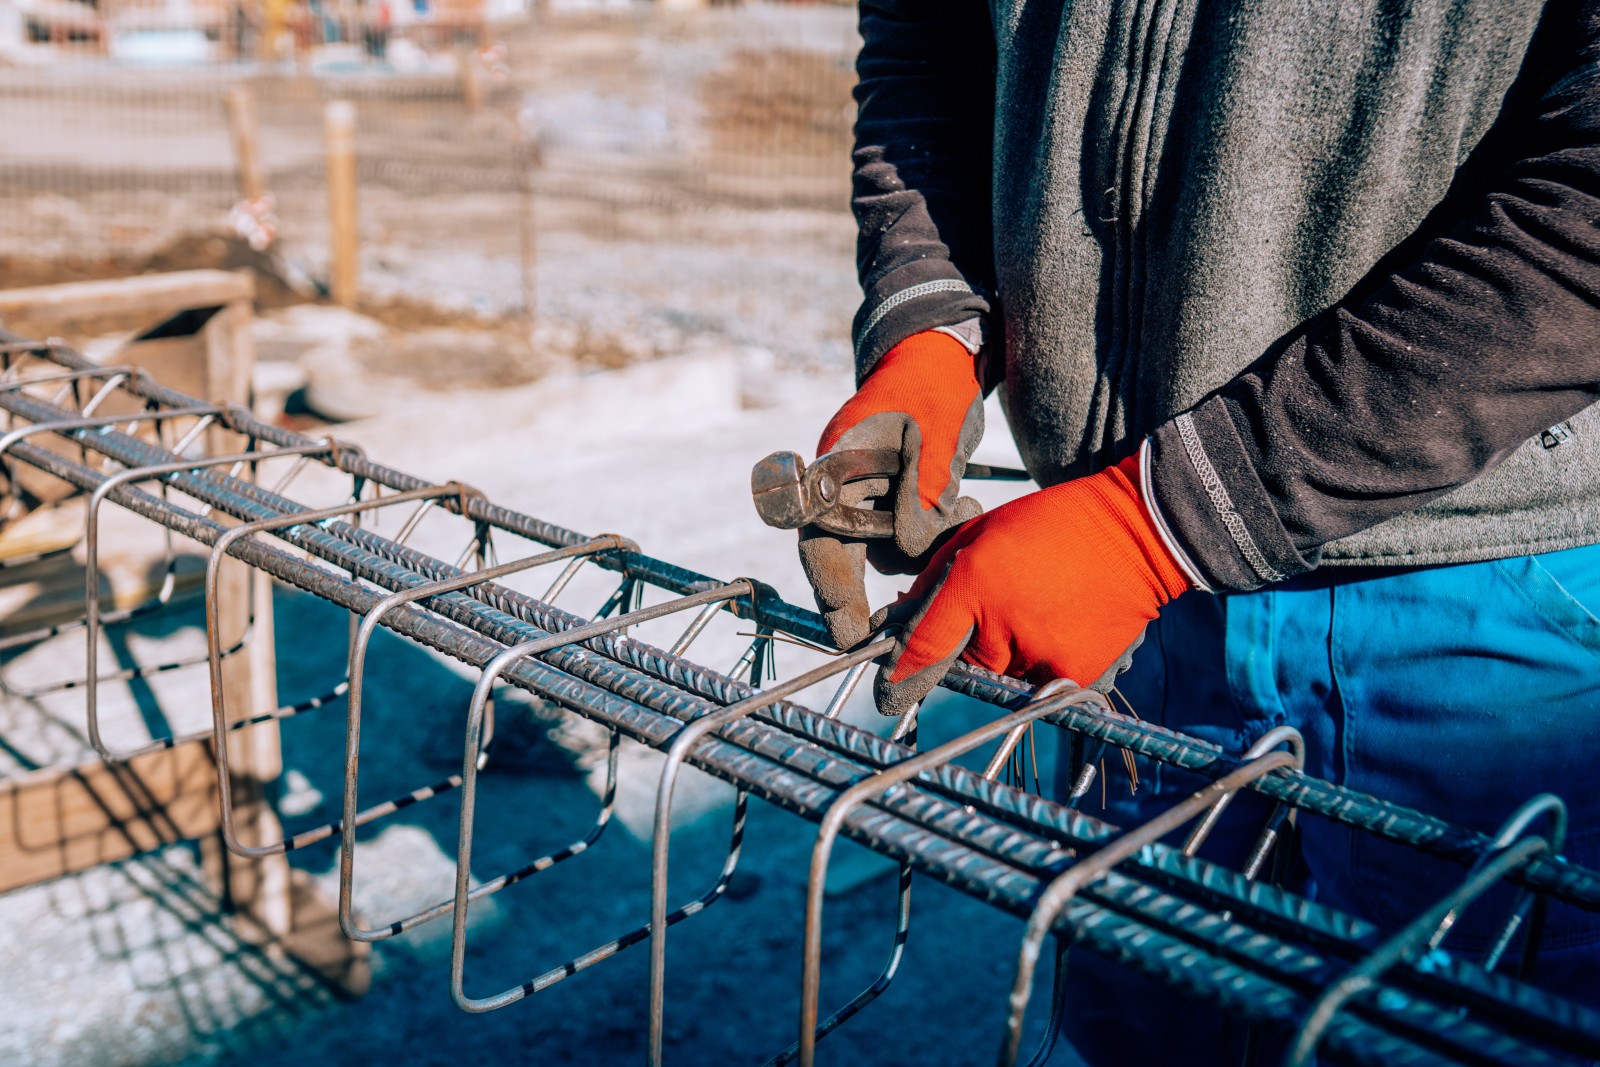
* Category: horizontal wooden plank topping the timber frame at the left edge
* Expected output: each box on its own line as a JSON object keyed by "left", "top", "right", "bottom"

{"left": 0, "top": 270, "right": 256, "bottom": 325}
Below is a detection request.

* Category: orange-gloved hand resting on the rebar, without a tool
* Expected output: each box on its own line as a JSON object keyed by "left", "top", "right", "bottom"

{"left": 872, "top": 456, "right": 1190, "bottom": 715}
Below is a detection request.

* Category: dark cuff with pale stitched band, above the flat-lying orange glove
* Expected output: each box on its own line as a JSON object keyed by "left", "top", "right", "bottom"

{"left": 1147, "top": 397, "right": 1315, "bottom": 590}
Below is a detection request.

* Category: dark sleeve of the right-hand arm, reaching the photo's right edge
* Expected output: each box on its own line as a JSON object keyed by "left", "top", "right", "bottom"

{"left": 1150, "top": 0, "right": 1600, "bottom": 589}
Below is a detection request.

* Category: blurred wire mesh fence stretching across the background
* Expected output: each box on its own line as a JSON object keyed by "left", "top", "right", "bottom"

{"left": 0, "top": 5, "right": 856, "bottom": 329}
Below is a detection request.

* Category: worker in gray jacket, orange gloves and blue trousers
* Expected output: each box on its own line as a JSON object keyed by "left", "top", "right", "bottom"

{"left": 800, "top": 0, "right": 1600, "bottom": 1064}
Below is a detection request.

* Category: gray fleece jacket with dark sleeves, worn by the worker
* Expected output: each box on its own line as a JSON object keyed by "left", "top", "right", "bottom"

{"left": 854, "top": 0, "right": 1600, "bottom": 589}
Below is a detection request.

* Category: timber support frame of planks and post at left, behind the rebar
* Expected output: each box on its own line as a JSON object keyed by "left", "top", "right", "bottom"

{"left": 0, "top": 270, "right": 370, "bottom": 993}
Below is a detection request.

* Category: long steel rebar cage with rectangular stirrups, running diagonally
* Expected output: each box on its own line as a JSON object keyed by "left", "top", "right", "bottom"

{"left": 0, "top": 329, "right": 1600, "bottom": 1064}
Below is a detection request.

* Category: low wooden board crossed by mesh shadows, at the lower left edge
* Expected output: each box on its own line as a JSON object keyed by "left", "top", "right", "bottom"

{"left": 0, "top": 742, "right": 219, "bottom": 893}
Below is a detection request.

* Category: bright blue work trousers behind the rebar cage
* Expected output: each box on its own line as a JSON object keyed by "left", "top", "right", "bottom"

{"left": 1058, "top": 545, "right": 1600, "bottom": 1067}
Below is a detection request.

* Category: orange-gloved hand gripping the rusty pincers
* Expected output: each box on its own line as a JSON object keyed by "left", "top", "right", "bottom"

{"left": 800, "top": 331, "right": 984, "bottom": 648}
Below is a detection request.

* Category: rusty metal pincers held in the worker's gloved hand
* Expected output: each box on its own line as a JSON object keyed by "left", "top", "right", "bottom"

{"left": 750, "top": 448, "right": 1032, "bottom": 537}
